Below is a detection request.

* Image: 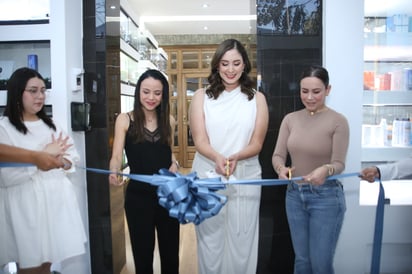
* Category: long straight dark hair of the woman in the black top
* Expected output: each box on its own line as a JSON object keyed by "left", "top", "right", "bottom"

{"left": 131, "top": 69, "right": 171, "bottom": 145}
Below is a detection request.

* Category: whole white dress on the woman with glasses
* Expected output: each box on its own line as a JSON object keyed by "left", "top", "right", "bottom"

{"left": 0, "top": 117, "right": 87, "bottom": 268}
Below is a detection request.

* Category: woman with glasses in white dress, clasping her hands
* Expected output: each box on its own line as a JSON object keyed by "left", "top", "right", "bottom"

{"left": 0, "top": 68, "right": 86, "bottom": 274}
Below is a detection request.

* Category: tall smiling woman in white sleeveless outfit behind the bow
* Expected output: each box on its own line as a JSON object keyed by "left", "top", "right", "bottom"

{"left": 190, "top": 39, "right": 269, "bottom": 274}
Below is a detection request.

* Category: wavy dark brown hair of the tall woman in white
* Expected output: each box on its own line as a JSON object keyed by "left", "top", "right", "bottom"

{"left": 206, "top": 39, "right": 255, "bottom": 100}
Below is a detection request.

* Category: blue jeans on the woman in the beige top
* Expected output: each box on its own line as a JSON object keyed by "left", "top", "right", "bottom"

{"left": 286, "top": 180, "right": 346, "bottom": 274}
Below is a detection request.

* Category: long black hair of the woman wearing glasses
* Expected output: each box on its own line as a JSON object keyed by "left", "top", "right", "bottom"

{"left": 4, "top": 67, "right": 56, "bottom": 134}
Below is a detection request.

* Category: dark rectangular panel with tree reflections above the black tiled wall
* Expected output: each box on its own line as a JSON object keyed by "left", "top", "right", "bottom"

{"left": 256, "top": 0, "right": 322, "bottom": 35}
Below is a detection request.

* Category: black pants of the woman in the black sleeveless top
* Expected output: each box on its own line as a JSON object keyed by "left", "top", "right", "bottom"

{"left": 125, "top": 182, "right": 180, "bottom": 274}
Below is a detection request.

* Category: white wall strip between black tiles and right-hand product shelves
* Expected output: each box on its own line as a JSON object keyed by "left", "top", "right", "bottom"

{"left": 323, "top": 0, "right": 374, "bottom": 274}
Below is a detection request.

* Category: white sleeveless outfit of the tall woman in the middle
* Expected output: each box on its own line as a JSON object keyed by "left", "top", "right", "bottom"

{"left": 192, "top": 87, "right": 261, "bottom": 274}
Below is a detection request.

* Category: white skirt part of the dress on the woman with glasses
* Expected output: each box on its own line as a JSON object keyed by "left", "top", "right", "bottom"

{"left": 0, "top": 168, "right": 87, "bottom": 268}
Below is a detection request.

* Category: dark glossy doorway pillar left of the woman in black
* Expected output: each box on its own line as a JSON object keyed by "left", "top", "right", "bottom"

{"left": 83, "top": 0, "right": 126, "bottom": 274}
